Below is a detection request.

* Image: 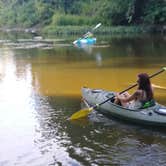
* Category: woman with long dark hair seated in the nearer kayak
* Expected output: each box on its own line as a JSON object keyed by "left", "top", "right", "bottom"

{"left": 114, "top": 73, "right": 154, "bottom": 109}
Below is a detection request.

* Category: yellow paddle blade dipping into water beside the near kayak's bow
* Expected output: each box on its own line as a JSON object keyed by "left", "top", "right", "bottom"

{"left": 69, "top": 107, "right": 93, "bottom": 120}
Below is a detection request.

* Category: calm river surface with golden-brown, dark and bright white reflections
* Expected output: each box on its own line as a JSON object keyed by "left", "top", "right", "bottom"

{"left": 0, "top": 33, "right": 166, "bottom": 166}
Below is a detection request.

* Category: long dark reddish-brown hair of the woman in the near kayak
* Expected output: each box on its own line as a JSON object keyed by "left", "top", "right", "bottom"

{"left": 138, "top": 73, "right": 153, "bottom": 100}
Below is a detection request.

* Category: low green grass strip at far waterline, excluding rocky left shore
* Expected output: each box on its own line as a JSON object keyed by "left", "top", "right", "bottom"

{"left": 41, "top": 26, "right": 165, "bottom": 35}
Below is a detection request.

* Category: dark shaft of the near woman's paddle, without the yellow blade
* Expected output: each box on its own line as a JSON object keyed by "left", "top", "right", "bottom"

{"left": 93, "top": 68, "right": 165, "bottom": 109}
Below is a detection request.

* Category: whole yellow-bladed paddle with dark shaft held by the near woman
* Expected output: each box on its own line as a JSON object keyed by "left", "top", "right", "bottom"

{"left": 69, "top": 67, "right": 166, "bottom": 120}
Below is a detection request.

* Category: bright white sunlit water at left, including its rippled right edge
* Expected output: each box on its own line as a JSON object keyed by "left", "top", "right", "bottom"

{"left": 0, "top": 51, "right": 79, "bottom": 166}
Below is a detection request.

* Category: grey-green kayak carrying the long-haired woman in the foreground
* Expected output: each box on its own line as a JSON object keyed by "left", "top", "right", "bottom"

{"left": 82, "top": 87, "right": 166, "bottom": 127}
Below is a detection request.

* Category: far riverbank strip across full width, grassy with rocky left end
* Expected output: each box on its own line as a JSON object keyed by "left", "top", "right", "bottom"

{"left": 0, "top": 25, "right": 166, "bottom": 35}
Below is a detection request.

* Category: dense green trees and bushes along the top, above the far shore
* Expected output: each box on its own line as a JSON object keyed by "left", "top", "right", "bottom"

{"left": 0, "top": 0, "right": 166, "bottom": 34}
